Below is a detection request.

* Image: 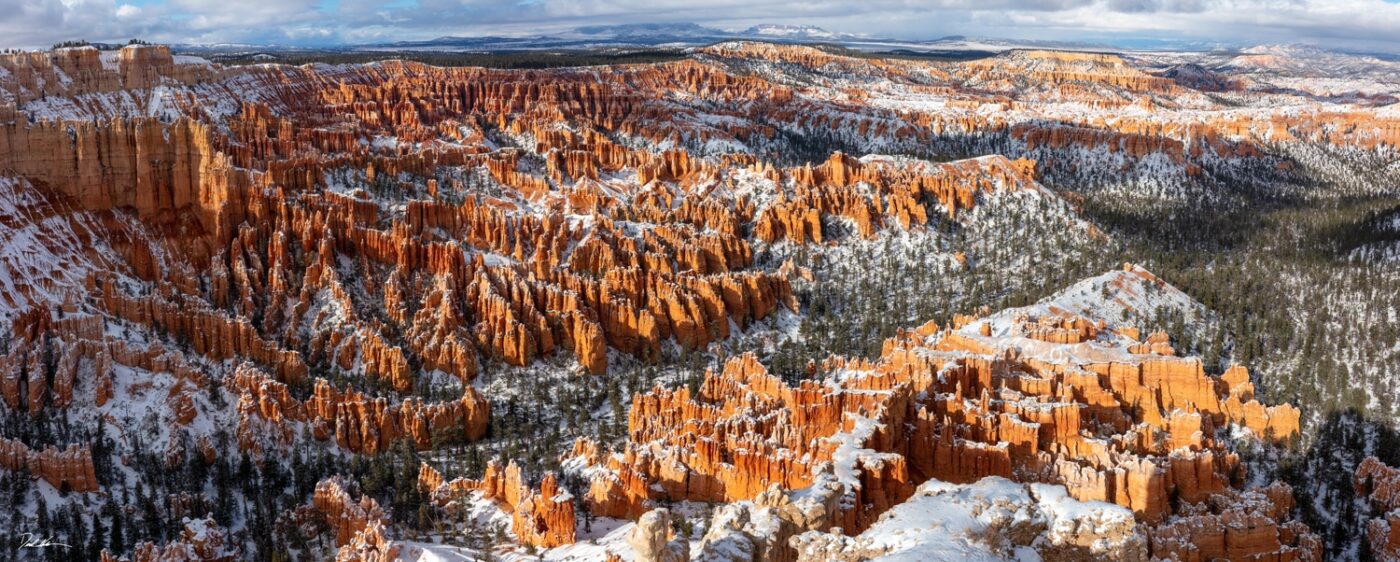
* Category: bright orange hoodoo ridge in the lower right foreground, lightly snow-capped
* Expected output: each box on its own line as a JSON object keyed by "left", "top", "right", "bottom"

{"left": 566, "top": 268, "right": 1320, "bottom": 559}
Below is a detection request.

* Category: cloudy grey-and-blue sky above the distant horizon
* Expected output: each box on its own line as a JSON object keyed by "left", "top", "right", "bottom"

{"left": 0, "top": 0, "right": 1400, "bottom": 53}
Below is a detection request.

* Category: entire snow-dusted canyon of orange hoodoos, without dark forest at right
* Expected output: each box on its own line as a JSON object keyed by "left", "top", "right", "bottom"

{"left": 0, "top": 42, "right": 1400, "bottom": 562}
